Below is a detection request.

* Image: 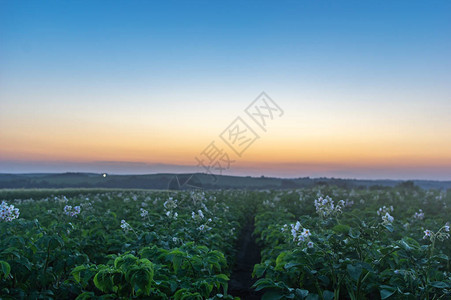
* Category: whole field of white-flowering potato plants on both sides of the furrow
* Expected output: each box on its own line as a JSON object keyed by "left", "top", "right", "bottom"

{"left": 0, "top": 186, "right": 451, "bottom": 300}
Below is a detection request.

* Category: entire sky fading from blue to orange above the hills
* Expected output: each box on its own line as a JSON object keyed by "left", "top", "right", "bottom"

{"left": 0, "top": 0, "right": 451, "bottom": 180}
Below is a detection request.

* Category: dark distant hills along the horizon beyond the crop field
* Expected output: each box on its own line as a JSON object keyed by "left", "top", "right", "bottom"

{"left": 0, "top": 173, "right": 451, "bottom": 190}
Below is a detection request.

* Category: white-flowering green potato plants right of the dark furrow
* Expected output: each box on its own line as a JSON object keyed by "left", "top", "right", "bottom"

{"left": 254, "top": 188, "right": 451, "bottom": 299}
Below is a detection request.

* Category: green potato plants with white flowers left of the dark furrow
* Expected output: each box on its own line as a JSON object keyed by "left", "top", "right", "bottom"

{"left": 0, "top": 191, "right": 253, "bottom": 299}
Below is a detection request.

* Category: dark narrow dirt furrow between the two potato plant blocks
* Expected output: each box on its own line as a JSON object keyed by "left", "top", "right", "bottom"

{"left": 229, "top": 220, "right": 262, "bottom": 300}
